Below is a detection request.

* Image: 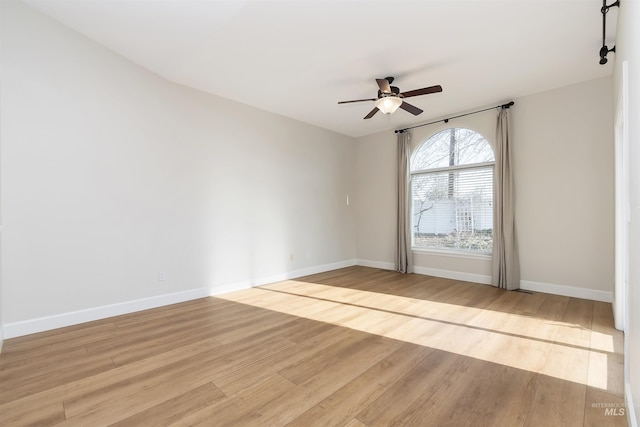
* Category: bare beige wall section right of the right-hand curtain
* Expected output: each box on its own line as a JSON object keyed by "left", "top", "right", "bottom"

{"left": 513, "top": 78, "right": 614, "bottom": 293}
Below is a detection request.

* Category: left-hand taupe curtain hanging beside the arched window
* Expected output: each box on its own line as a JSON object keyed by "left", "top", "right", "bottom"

{"left": 395, "top": 131, "right": 413, "bottom": 273}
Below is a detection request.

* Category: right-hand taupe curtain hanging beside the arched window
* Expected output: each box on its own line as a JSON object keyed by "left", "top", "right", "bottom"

{"left": 491, "top": 107, "right": 520, "bottom": 290}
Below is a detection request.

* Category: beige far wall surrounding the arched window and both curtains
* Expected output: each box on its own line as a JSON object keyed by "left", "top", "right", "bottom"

{"left": 356, "top": 78, "right": 614, "bottom": 300}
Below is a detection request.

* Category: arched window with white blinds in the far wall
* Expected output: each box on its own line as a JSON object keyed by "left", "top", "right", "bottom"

{"left": 411, "top": 128, "right": 495, "bottom": 254}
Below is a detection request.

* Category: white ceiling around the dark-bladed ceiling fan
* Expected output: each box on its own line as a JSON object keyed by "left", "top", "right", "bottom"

{"left": 26, "top": 0, "right": 617, "bottom": 137}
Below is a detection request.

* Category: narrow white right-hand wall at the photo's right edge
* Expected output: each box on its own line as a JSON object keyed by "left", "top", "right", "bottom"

{"left": 609, "top": 1, "right": 640, "bottom": 425}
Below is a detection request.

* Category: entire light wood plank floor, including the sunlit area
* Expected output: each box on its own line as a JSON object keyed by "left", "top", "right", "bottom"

{"left": 0, "top": 267, "right": 626, "bottom": 427}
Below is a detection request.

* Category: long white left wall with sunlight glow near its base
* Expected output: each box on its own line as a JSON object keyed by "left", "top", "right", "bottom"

{"left": 0, "top": 1, "right": 356, "bottom": 336}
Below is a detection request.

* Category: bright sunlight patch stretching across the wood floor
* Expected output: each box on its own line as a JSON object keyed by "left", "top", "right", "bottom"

{"left": 218, "top": 280, "right": 615, "bottom": 390}
